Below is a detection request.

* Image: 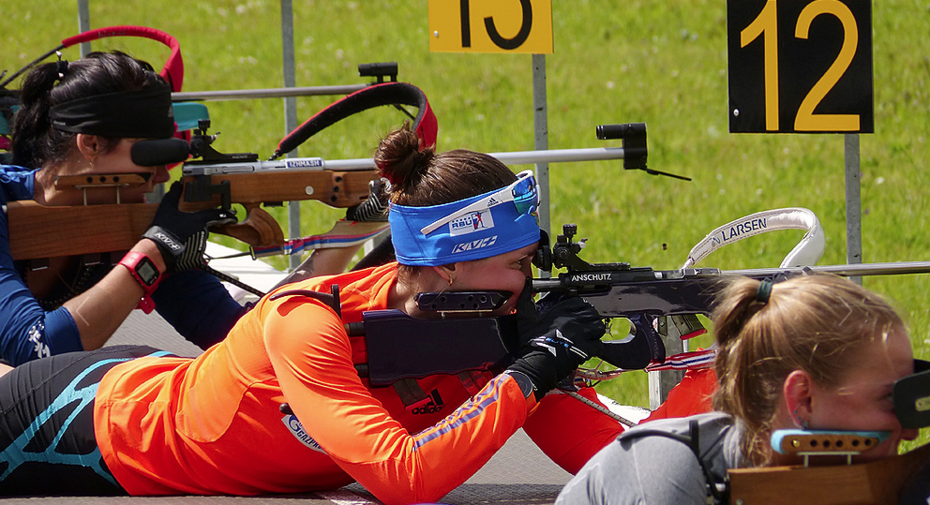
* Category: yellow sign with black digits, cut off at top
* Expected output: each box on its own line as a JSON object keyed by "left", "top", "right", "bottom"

{"left": 429, "top": 0, "right": 552, "bottom": 54}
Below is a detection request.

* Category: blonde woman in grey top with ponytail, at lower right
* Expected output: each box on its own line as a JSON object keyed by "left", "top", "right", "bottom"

{"left": 556, "top": 275, "right": 917, "bottom": 505}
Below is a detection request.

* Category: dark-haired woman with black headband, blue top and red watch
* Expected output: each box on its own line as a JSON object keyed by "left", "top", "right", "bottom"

{"left": 0, "top": 52, "right": 244, "bottom": 364}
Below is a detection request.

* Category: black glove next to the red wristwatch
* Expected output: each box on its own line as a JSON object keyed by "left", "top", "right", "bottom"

{"left": 142, "top": 182, "right": 236, "bottom": 272}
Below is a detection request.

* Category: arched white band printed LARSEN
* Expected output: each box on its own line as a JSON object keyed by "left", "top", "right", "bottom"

{"left": 682, "top": 207, "right": 825, "bottom": 268}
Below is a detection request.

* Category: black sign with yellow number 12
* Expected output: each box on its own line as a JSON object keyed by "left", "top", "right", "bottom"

{"left": 727, "top": 0, "right": 875, "bottom": 133}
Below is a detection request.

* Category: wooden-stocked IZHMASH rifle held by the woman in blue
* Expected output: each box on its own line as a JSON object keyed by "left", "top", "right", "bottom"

{"left": 5, "top": 114, "right": 648, "bottom": 260}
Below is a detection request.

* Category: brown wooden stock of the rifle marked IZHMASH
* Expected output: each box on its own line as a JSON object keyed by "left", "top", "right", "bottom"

{"left": 6, "top": 170, "right": 380, "bottom": 260}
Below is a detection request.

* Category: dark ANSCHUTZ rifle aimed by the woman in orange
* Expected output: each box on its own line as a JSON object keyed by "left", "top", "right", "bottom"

{"left": 350, "top": 224, "right": 930, "bottom": 386}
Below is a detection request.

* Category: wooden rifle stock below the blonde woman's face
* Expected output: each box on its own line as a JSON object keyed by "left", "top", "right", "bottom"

{"left": 729, "top": 445, "right": 930, "bottom": 505}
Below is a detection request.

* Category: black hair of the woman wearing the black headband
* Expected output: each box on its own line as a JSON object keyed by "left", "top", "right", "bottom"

{"left": 12, "top": 51, "right": 164, "bottom": 168}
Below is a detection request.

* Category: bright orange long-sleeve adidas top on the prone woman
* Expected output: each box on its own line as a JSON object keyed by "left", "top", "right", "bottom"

{"left": 94, "top": 264, "right": 622, "bottom": 504}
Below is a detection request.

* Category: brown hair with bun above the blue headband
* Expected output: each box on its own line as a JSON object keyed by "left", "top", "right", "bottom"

{"left": 374, "top": 123, "right": 517, "bottom": 276}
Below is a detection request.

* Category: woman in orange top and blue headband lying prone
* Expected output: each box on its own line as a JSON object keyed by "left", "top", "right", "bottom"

{"left": 0, "top": 128, "right": 623, "bottom": 504}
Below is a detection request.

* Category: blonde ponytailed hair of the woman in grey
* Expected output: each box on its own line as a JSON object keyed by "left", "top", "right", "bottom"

{"left": 711, "top": 274, "right": 906, "bottom": 465}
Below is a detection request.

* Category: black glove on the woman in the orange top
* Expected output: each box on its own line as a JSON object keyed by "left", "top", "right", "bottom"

{"left": 508, "top": 283, "right": 607, "bottom": 401}
